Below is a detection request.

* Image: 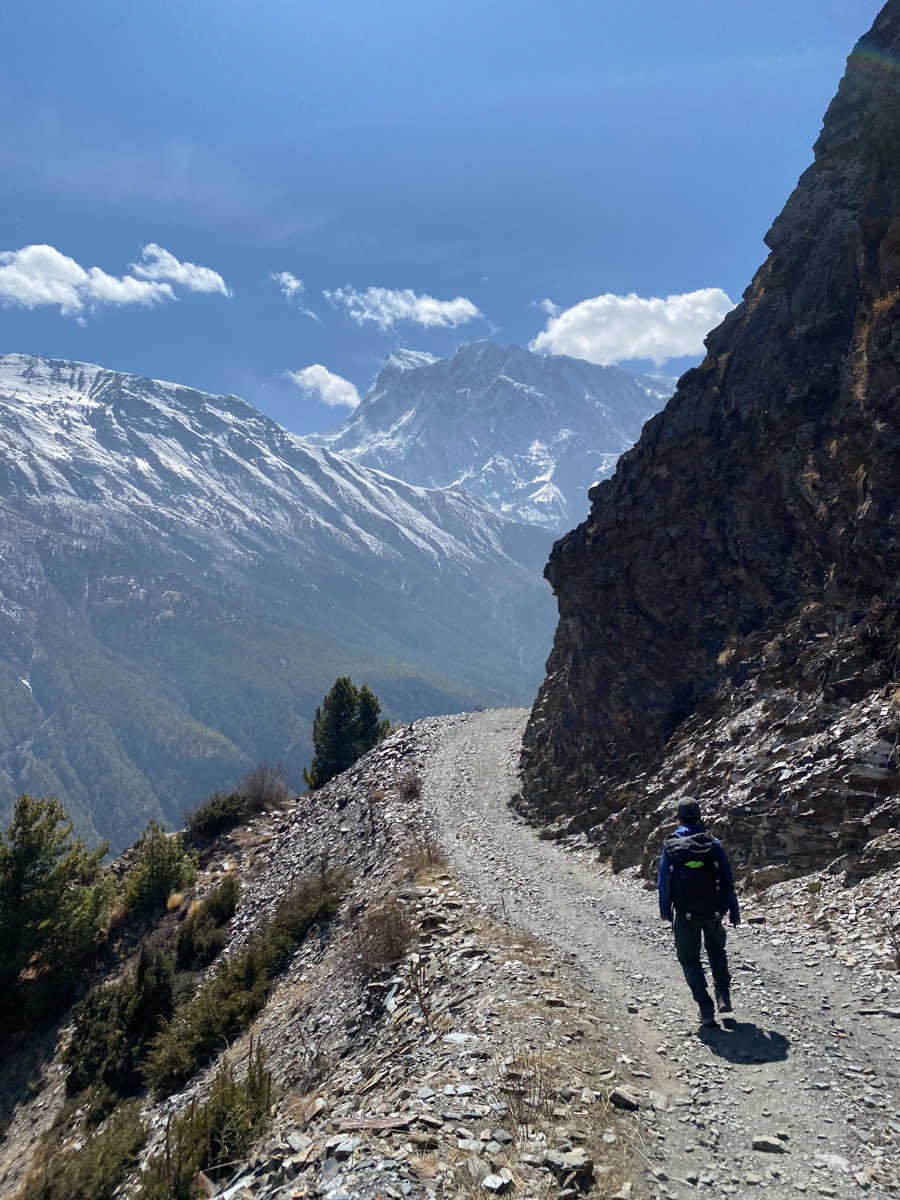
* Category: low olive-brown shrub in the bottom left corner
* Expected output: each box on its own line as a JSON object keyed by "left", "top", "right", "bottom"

{"left": 17, "top": 1102, "right": 145, "bottom": 1200}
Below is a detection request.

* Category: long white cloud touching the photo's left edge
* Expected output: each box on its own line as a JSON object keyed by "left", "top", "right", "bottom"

{"left": 0, "top": 245, "right": 230, "bottom": 320}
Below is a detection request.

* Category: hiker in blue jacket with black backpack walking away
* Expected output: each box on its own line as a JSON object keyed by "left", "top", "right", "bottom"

{"left": 656, "top": 799, "right": 740, "bottom": 1026}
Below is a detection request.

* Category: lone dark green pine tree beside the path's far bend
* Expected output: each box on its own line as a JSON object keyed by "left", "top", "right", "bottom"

{"left": 304, "top": 676, "right": 390, "bottom": 788}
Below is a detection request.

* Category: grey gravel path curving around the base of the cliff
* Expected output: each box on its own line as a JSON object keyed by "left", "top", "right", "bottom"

{"left": 424, "top": 709, "right": 900, "bottom": 1198}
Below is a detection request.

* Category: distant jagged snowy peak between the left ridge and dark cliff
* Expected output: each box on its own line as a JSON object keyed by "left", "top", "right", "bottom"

{"left": 313, "top": 341, "right": 674, "bottom": 530}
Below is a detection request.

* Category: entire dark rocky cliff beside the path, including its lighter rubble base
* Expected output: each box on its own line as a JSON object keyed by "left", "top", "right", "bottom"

{"left": 522, "top": 0, "right": 900, "bottom": 874}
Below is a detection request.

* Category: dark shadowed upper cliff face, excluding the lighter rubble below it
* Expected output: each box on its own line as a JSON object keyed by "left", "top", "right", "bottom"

{"left": 522, "top": 0, "right": 900, "bottom": 860}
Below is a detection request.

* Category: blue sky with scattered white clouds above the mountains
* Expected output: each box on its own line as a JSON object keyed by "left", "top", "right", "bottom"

{"left": 0, "top": 0, "right": 880, "bottom": 432}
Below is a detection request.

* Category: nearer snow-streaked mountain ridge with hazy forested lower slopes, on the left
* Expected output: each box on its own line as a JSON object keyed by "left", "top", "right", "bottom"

{"left": 0, "top": 354, "right": 553, "bottom": 844}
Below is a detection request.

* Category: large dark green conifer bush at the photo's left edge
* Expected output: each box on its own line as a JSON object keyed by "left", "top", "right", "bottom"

{"left": 0, "top": 796, "right": 113, "bottom": 1024}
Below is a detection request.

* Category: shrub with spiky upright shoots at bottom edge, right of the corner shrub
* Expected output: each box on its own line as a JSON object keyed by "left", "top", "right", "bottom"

{"left": 139, "top": 1043, "right": 272, "bottom": 1200}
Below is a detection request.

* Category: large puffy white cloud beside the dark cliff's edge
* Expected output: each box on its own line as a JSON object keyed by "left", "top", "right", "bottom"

{"left": 529, "top": 288, "right": 734, "bottom": 365}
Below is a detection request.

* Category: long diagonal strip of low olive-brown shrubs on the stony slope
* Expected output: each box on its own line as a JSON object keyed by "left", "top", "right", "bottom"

{"left": 143, "top": 869, "right": 348, "bottom": 1094}
